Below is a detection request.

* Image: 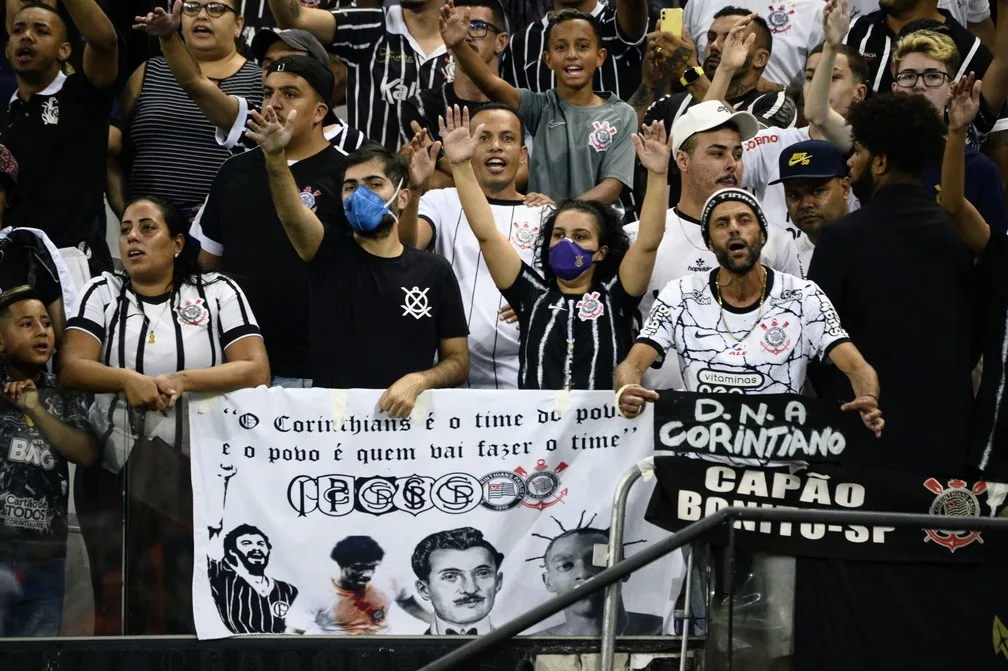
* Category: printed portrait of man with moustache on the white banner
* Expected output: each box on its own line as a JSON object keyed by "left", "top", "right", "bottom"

{"left": 412, "top": 527, "right": 504, "bottom": 636}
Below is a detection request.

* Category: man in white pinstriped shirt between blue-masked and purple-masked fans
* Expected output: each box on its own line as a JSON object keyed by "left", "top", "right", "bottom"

{"left": 399, "top": 103, "right": 551, "bottom": 389}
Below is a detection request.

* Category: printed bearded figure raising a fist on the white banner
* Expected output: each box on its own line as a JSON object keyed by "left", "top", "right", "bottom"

{"left": 207, "top": 463, "right": 297, "bottom": 634}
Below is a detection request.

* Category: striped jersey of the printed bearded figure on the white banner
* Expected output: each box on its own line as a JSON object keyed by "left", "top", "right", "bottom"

{"left": 207, "top": 558, "right": 297, "bottom": 634}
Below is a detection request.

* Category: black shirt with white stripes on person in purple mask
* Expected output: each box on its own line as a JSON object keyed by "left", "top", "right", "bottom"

{"left": 501, "top": 263, "right": 641, "bottom": 389}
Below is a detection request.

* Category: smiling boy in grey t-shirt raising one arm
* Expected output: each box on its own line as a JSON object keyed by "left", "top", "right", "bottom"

{"left": 440, "top": 0, "right": 637, "bottom": 205}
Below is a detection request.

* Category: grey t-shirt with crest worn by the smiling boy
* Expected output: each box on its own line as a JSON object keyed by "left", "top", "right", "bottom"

{"left": 518, "top": 89, "right": 637, "bottom": 203}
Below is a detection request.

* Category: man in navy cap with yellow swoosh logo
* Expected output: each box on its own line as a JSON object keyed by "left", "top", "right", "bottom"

{"left": 771, "top": 140, "right": 851, "bottom": 279}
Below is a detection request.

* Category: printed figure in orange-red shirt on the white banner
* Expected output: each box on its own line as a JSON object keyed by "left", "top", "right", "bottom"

{"left": 287, "top": 536, "right": 430, "bottom": 636}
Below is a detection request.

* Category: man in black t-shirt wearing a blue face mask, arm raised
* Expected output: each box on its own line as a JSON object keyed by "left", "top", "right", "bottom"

{"left": 250, "top": 91, "right": 469, "bottom": 417}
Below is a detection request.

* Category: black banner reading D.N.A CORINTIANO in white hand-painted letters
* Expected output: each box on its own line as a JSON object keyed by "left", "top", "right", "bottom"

{"left": 654, "top": 392, "right": 877, "bottom": 464}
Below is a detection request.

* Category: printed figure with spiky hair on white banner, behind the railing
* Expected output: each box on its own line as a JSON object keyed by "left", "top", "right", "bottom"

{"left": 528, "top": 513, "right": 663, "bottom": 636}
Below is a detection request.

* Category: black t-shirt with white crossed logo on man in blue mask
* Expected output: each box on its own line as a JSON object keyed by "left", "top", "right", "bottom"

{"left": 310, "top": 230, "right": 469, "bottom": 389}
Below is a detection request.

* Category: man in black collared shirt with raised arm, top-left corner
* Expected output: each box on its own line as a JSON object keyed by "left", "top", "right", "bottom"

{"left": 0, "top": 0, "right": 119, "bottom": 274}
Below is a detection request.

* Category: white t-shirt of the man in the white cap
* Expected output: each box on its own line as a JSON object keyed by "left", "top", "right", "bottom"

{"left": 625, "top": 208, "right": 801, "bottom": 389}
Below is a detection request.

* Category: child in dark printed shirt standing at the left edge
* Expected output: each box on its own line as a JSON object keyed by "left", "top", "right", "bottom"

{"left": 0, "top": 286, "right": 98, "bottom": 637}
